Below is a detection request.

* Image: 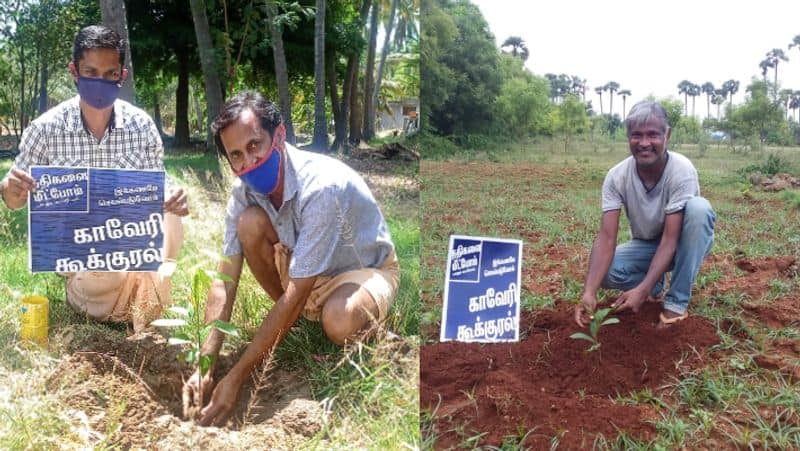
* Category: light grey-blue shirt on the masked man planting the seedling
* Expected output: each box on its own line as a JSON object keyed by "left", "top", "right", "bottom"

{"left": 223, "top": 144, "right": 394, "bottom": 278}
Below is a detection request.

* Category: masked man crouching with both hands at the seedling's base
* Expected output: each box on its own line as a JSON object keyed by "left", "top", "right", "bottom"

{"left": 183, "top": 92, "right": 399, "bottom": 426}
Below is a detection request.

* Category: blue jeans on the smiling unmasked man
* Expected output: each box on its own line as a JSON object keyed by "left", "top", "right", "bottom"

{"left": 602, "top": 197, "right": 717, "bottom": 314}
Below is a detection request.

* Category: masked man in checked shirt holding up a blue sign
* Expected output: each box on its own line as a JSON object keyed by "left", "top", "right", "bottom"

{"left": 0, "top": 26, "right": 189, "bottom": 331}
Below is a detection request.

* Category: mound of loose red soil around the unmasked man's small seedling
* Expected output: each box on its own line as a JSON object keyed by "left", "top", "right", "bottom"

{"left": 420, "top": 304, "right": 719, "bottom": 449}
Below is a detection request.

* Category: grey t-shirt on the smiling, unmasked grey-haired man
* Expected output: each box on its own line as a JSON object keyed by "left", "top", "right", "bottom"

{"left": 602, "top": 151, "right": 700, "bottom": 240}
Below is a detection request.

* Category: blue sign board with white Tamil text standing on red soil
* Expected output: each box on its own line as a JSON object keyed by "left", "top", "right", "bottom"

{"left": 440, "top": 235, "right": 522, "bottom": 343}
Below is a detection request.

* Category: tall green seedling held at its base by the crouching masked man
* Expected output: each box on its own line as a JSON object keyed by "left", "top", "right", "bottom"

{"left": 152, "top": 268, "right": 239, "bottom": 411}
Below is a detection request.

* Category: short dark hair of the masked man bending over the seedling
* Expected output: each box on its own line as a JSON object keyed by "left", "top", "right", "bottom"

{"left": 211, "top": 91, "right": 282, "bottom": 160}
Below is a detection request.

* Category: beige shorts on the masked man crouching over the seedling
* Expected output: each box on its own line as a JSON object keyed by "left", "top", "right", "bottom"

{"left": 274, "top": 243, "right": 400, "bottom": 321}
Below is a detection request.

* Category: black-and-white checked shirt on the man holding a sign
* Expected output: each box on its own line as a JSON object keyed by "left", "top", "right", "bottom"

{"left": 6, "top": 96, "right": 164, "bottom": 177}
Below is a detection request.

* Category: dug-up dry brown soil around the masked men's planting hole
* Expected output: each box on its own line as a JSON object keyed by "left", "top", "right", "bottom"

{"left": 47, "top": 325, "right": 323, "bottom": 449}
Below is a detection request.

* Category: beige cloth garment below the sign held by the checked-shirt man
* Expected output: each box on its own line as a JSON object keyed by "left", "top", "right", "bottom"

{"left": 63, "top": 272, "right": 172, "bottom": 331}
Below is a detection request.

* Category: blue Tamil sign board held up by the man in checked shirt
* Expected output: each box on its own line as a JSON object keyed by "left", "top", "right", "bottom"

{"left": 28, "top": 166, "right": 164, "bottom": 272}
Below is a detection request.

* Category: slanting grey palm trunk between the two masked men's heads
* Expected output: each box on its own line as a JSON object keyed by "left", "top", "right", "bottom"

{"left": 189, "top": 0, "right": 223, "bottom": 150}
